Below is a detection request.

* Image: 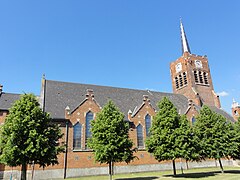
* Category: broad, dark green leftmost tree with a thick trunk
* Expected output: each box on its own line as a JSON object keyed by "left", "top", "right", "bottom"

{"left": 0, "top": 94, "right": 63, "bottom": 180}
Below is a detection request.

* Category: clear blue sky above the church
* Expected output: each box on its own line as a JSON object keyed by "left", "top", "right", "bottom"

{"left": 0, "top": 0, "right": 240, "bottom": 112}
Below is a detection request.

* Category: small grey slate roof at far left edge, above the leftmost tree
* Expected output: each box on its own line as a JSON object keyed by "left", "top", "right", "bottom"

{"left": 0, "top": 92, "right": 20, "bottom": 110}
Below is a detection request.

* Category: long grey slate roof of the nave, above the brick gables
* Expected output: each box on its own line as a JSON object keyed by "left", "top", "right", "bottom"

{"left": 45, "top": 80, "right": 188, "bottom": 119}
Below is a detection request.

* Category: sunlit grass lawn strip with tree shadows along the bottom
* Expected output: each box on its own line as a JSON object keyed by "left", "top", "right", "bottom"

{"left": 68, "top": 167, "right": 240, "bottom": 180}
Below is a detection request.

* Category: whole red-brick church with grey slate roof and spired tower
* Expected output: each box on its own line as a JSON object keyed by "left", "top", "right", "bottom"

{"left": 0, "top": 22, "right": 233, "bottom": 178}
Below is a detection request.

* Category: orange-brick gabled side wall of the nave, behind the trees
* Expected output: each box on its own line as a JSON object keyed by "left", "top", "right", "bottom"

{"left": 0, "top": 90, "right": 197, "bottom": 173}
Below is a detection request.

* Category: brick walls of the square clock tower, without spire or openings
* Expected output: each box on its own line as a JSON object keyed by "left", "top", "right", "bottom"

{"left": 170, "top": 52, "right": 221, "bottom": 108}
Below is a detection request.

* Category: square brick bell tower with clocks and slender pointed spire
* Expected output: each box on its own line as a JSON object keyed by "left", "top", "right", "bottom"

{"left": 170, "top": 20, "right": 221, "bottom": 108}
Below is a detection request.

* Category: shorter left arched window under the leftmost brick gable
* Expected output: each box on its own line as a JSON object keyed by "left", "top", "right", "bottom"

{"left": 73, "top": 122, "right": 82, "bottom": 149}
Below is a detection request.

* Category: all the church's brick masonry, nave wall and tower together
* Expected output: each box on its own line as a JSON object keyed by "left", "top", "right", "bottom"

{"left": 0, "top": 52, "right": 232, "bottom": 178}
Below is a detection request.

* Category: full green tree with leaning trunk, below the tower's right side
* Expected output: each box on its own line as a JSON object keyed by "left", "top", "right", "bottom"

{"left": 194, "top": 106, "right": 233, "bottom": 173}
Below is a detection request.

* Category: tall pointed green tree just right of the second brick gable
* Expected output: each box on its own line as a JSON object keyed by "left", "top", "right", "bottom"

{"left": 146, "top": 97, "right": 181, "bottom": 175}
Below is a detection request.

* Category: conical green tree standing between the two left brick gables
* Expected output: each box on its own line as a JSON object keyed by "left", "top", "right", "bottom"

{"left": 88, "top": 101, "right": 135, "bottom": 179}
